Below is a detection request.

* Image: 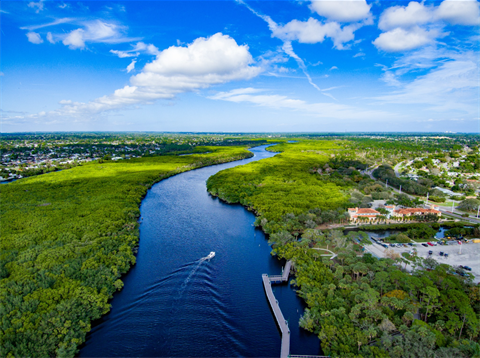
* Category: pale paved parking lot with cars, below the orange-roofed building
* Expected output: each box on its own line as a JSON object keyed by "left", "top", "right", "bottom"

{"left": 365, "top": 241, "right": 480, "bottom": 283}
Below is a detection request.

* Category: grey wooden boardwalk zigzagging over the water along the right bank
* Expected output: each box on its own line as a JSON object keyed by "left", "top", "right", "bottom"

{"left": 262, "top": 261, "right": 325, "bottom": 358}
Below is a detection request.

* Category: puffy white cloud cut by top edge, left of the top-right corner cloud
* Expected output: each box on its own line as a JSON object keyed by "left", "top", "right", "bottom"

{"left": 310, "top": 0, "right": 371, "bottom": 22}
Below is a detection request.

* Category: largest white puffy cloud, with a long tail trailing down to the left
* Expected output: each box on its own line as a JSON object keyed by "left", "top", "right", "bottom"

{"left": 12, "top": 33, "right": 262, "bottom": 118}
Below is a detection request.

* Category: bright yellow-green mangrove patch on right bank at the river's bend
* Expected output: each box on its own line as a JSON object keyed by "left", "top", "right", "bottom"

{"left": 207, "top": 141, "right": 353, "bottom": 233}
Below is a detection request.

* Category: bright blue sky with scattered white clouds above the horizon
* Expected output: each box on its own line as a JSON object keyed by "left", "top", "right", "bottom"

{"left": 0, "top": 0, "right": 480, "bottom": 132}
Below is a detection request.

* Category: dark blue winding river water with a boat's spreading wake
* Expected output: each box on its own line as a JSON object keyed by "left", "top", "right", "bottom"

{"left": 79, "top": 146, "right": 320, "bottom": 358}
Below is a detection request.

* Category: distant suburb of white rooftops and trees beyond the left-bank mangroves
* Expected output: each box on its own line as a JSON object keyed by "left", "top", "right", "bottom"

{"left": 0, "top": 132, "right": 267, "bottom": 180}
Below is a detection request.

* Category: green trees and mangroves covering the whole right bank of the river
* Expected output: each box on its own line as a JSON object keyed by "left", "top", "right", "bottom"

{"left": 207, "top": 140, "right": 480, "bottom": 358}
